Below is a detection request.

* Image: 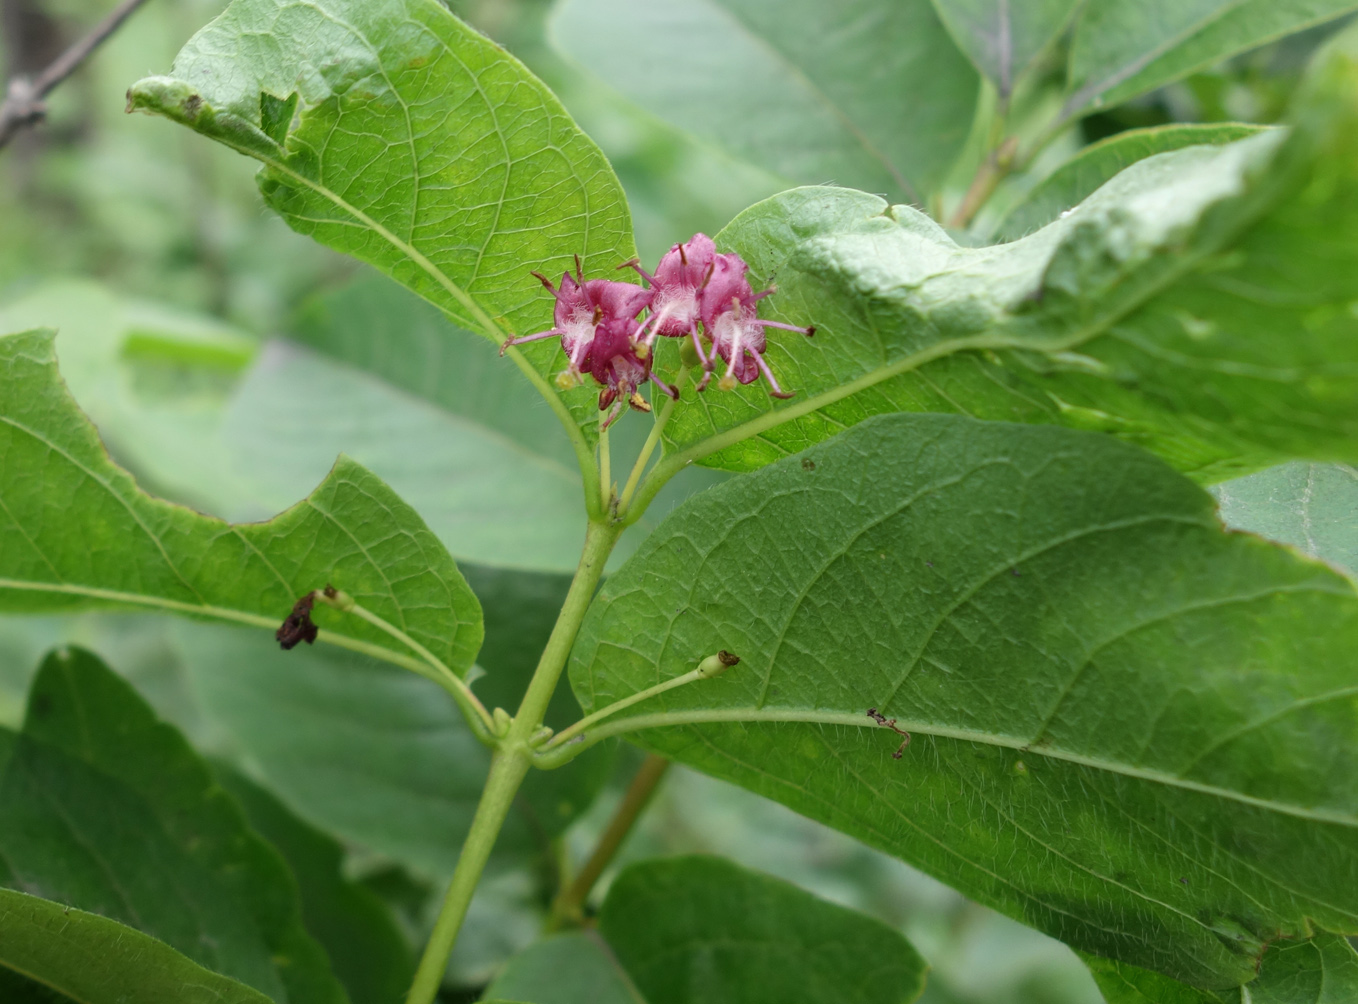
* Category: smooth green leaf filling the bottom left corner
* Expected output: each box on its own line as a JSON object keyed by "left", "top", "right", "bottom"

{"left": 0, "top": 889, "right": 269, "bottom": 1004}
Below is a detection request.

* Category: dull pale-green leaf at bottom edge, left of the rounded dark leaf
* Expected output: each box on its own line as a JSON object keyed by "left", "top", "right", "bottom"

{"left": 485, "top": 931, "right": 646, "bottom": 1004}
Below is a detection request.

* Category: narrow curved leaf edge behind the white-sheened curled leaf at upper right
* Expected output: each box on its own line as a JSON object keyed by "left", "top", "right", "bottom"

{"left": 994, "top": 122, "right": 1266, "bottom": 240}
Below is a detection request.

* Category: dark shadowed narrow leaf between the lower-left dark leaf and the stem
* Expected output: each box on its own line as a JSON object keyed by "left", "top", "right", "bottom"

{"left": 213, "top": 765, "right": 414, "bottom": 1004}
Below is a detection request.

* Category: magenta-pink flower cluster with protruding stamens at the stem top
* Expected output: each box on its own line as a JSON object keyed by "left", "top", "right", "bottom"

{"left": 501, "top": 234, "right": 816, "bottom": 425}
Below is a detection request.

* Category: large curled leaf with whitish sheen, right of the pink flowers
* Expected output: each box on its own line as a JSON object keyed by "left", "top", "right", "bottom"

{"left": 667, "top": 44, "right": 1358, "bottom": 480}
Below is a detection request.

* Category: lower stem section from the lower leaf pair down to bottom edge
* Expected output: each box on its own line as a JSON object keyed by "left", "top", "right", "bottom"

{"left": 406, "top": 750, "right": 530, "bottom": 1004}
